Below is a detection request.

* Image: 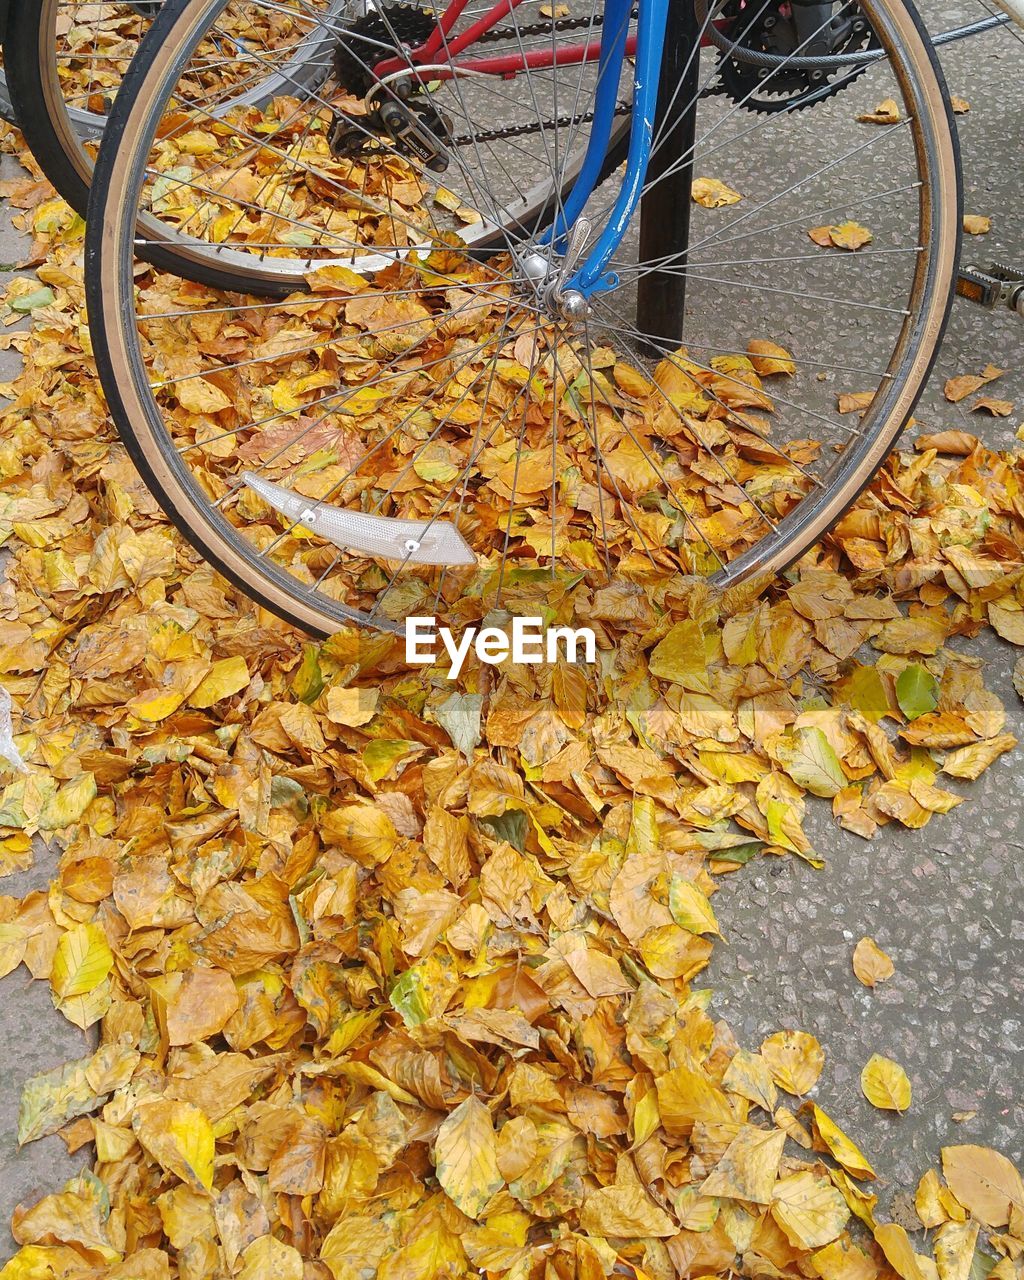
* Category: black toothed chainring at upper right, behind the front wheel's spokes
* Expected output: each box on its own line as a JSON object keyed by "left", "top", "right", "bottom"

{"left": 716, "top": 0, "right": 878, "bottom": 114}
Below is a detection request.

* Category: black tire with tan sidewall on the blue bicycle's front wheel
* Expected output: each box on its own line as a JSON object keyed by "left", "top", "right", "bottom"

{"left": 87, "top": 0, "right": 963, "bottom": 635}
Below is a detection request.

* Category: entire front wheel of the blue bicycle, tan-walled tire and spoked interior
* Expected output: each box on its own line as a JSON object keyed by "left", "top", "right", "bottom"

{"left": 87, "top": 0, "right": 960, "bottom": 634}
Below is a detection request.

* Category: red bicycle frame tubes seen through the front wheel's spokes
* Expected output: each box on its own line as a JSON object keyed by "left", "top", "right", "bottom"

{"left": 374, "top": 0, "right": 709, "bottom": 79}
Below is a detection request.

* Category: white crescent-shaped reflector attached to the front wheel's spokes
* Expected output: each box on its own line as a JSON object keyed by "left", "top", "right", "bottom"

{"left": 242, "top": 471, "right": 476, "bottom": 568}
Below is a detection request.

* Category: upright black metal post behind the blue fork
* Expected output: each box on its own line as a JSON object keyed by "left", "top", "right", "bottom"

{"left": 636, "top": 0, "right": 700, "bottom": 357}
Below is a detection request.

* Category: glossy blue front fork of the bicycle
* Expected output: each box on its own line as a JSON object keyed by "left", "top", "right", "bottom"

{"left": 540, "top": 0, "right": 685, "bottom": 298}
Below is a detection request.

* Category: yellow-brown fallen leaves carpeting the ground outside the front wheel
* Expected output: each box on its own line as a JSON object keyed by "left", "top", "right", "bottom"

{"left": 0, "top": 140, "right": 1024, "bottom": 1280}
